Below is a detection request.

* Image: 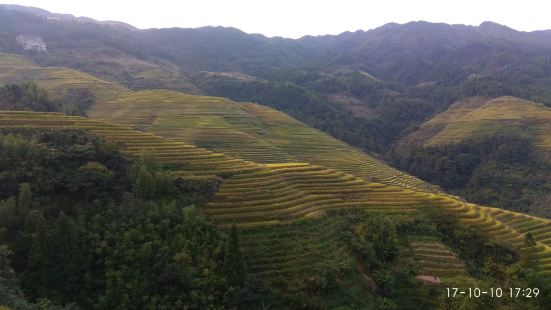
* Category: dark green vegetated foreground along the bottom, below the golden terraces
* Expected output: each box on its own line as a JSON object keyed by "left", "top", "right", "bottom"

{"left": 0, "top": 125, "right": 547, "bottom": 309}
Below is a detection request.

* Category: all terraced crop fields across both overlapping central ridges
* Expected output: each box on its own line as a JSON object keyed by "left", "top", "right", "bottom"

{"left": 0, "top": 56, "right": 551, "bottom": 284}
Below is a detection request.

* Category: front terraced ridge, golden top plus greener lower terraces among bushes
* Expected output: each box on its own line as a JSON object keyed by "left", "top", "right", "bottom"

{"left": 0, "top": 112, "right": 551, "bottom": 304}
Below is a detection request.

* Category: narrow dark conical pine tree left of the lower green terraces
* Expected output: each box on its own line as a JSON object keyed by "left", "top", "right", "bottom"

{"left": 224, "top": 224, "right": 247, "bottom": 286}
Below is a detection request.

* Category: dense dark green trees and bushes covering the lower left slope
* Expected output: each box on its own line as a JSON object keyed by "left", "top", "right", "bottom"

{"left": 0, "top": 130, "right": 250, "bottom": 309}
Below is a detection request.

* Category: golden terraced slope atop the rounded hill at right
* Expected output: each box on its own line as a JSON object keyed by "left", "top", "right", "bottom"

{"left": 404, "top": 97, "right": 551, "bottom": 151}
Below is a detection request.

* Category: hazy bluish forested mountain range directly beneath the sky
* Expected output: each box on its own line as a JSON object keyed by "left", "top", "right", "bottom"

{"left": 0, "top": 5, "right": 551, "bottom": 152}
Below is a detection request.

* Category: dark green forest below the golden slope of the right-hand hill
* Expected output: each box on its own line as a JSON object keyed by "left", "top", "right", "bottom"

{"left": 393, "top": 131, "right": 551, "bottom": 217}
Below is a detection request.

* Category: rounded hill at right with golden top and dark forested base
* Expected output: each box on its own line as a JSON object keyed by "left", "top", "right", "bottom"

{"left": 393, "top": 97, "right": 551, "bottom": 217}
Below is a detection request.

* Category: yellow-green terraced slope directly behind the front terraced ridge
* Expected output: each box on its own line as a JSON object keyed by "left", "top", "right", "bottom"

{"left": 88, "top": 90, "right": 436, "bottom": 190}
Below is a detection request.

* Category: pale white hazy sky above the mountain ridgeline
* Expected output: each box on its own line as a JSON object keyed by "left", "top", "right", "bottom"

{"left": 4, "top": 0, "right": 551, "bottom": 38}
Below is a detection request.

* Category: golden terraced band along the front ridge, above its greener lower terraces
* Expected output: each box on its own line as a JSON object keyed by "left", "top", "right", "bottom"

{"left": 0, "top": 111, "right": 551, "bottom": 276}
